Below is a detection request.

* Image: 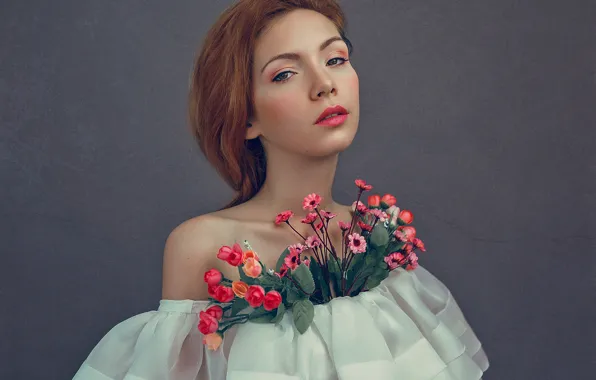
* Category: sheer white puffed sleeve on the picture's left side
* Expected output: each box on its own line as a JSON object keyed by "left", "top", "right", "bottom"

{"left": 73, "top": 300, "right": 232, "bottom": 380}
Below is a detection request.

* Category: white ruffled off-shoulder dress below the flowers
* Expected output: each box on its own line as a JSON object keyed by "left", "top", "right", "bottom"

{"left": 74, "top": 266, "right": 488, "bottom": 380}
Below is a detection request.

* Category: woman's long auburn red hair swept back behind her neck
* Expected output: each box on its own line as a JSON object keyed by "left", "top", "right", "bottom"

{"left": 188, "top": 0, "right": 352, "bottom": 209}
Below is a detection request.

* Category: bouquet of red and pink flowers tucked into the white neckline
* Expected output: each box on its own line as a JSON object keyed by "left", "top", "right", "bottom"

{"left": 198, "top": 179, "right": 426, "bottom": 350}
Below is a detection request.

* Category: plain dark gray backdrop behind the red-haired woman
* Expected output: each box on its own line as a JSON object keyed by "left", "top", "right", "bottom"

{"left": 0, "top": 0, "right": 596, "bottom": 380}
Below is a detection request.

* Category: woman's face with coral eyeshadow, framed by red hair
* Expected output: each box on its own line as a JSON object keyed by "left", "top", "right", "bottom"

{"left": 246, "top": 9, "right": 360, "bottom": 157}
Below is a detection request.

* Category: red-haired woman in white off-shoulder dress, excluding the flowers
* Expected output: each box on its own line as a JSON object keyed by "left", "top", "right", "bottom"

{"left": 75, "top": 0, "right": 488, "bottom": 380}
